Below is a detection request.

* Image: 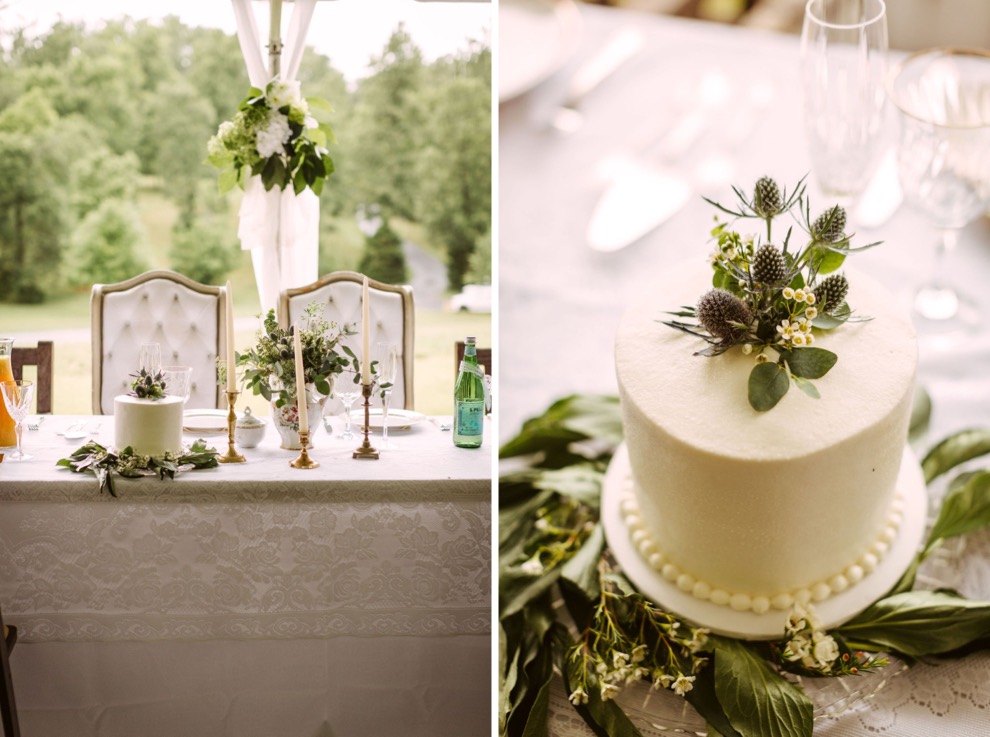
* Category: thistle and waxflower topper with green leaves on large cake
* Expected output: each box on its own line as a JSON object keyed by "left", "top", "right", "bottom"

{"left": 664, "top": 177, "right": 878, "bottom": 412}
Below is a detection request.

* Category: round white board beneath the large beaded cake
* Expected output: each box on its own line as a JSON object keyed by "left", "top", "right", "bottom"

{"left": 601, "top": 444, "right": 928, "bottom": 640}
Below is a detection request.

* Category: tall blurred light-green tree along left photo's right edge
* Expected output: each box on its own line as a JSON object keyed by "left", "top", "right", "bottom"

{"left": 419, "top": 76, "right": 492, "bottom": 289}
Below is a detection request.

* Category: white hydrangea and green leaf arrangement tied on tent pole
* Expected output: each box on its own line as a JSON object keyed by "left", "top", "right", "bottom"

{"left": 207, "top": 78, "right": 335, "bottom": 195}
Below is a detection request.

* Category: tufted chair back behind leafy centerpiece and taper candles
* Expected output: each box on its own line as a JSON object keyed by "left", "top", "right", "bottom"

{"left": 278, "top": 271, "right": 415, "bottom": 415}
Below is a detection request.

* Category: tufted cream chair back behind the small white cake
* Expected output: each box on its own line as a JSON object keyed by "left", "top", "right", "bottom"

{"left": 90, "top": 271, "right": 227, "bottom": 414}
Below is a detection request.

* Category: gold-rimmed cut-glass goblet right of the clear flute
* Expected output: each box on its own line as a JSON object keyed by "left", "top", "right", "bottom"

{"left": 891, "top": 49, "right": 990, "bottom": 331}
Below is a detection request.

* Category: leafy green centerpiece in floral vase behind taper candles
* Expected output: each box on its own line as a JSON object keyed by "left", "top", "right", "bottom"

{"left": 235, "top": 302, "right": 354, "bottom": 408}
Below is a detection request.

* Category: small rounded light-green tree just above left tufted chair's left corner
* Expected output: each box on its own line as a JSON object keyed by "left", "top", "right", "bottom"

{"left": 68, "top": 200, "right": 146, "bottom": 286}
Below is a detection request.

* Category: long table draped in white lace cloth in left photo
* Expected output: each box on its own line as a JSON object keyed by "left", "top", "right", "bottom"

{"left": 0, "top": 416, "right": 491, "bottom": 737}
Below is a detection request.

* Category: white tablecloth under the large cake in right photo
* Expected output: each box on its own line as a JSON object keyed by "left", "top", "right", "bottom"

{"left": 499, "top": 6, "right": 990, "bottom": 737}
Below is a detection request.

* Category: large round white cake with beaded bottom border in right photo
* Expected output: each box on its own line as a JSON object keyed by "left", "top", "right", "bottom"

{"left": 615, "top": 262, "right": 917, "bottom": 614}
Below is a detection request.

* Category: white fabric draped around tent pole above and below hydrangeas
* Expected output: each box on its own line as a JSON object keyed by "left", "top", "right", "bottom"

{"left": 231, "top": 0, "right": 320, "bottom": 311}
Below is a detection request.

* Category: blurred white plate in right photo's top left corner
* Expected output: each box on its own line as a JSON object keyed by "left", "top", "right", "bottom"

{"left": 498, "top": 0, "right": 581, "bottom": 102}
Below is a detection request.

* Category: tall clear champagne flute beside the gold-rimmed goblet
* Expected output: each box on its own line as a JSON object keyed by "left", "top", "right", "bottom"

{"left": 801, "top": 0, "right": 887, "bottom": 206}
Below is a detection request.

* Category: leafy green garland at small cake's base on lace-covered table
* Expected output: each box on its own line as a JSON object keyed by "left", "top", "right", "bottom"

{"left": 56, "top": 439, "right": 219, "bottom": 497}
